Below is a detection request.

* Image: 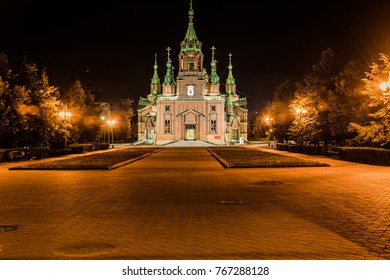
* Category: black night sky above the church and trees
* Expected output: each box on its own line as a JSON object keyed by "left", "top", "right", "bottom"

{"left": 0, "top": 0, "right": 390, "bottom": 109}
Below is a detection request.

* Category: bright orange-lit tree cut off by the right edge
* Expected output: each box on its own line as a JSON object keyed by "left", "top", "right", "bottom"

{"left": 350, "top": 53, "right": 390, "bottom": 148}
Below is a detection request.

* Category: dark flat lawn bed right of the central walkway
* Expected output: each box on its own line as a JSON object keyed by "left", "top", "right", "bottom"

{"left": 208, "top": 147, "right": 329, "bottom": 168}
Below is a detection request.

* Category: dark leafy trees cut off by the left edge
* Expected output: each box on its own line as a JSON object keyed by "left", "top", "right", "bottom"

{"left": 0, "top": 54, "right": 61, "bottom": 147}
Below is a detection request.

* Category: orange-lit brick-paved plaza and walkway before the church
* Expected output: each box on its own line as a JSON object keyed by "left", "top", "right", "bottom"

{"left": 0, "top": 145, "right": 390, "bottom": 260}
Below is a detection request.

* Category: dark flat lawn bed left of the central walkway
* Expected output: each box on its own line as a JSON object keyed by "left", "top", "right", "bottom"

{"left": 9, "top": 147, "right": 161, "bottom": 170}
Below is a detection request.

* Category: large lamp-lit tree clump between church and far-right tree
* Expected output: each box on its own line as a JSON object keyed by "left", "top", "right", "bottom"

{"left": 271, "top": 49, "right": 368, "bottom": 145}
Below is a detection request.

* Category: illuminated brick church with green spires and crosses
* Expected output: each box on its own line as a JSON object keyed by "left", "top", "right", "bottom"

{"left": 137, "top": 1, "right": 248, "bottom": 145}
